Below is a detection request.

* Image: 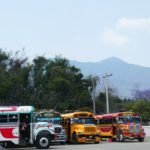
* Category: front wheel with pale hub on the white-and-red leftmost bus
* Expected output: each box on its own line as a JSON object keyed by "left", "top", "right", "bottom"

{"left": 36, "top": 135, "right": 51, "bottom": 149}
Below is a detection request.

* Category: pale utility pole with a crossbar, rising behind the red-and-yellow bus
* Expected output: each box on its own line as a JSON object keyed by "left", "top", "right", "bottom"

{"left": 103, "top": 74, "right": 112, "bottom": 114}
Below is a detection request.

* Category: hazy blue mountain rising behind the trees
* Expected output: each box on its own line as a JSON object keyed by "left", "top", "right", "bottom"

{"left": 70, "top": 57, "right": 150, "bottom": 98}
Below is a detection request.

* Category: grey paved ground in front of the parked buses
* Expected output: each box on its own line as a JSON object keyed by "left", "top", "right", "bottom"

{"left": 2, "top": 141, "right": 150, "bottom": 150}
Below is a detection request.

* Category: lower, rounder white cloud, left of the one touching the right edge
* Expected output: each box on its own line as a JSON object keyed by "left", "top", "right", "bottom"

{"left": 101, "top": 29, "right": 129, "bottom": 46}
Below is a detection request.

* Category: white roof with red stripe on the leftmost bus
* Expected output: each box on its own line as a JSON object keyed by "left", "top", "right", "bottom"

{"left": 0, "top": 106, "right": 34, "bottom": 113}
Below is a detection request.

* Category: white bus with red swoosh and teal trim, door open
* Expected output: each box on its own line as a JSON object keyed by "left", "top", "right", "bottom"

{"left": 0, "top": 106, "right": 55, "bottom": 148}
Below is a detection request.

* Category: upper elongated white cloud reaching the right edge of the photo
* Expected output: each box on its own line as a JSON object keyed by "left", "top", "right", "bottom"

{"left": 117, "top": 18, "right": 150, "bottom": 28}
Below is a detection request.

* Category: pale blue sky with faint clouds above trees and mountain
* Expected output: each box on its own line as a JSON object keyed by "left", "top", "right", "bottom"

{"left": 0, "top": 0, "right": 150, "bottom": 67}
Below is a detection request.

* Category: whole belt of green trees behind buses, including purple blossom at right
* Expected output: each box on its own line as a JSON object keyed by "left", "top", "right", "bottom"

{"left": 0, "top": 50, "right": 150, "bottom": 120}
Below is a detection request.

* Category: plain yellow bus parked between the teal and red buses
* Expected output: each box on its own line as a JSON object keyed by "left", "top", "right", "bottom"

{"left": 61, "top": 111, "right": 101, "bottom": 144}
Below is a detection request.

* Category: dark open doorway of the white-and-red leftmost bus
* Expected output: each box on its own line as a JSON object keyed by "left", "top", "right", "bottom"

{"left": 19, "top": 113, "right": 32, "bottom": 142}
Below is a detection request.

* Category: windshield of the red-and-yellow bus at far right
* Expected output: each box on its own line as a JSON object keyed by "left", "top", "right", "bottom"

{"left": 118, "top": 116, "right": 141, "bottom": 123}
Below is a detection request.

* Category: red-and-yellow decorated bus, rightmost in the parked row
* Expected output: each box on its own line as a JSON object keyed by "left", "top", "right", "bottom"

{"left": 95, "top": 112, "right": 145, "bottom": 142}
